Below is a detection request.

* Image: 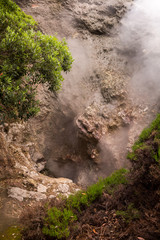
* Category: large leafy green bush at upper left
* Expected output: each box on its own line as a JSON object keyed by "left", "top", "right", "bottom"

{"left": 0, "top": 0, "right": 73, "bottom": 122}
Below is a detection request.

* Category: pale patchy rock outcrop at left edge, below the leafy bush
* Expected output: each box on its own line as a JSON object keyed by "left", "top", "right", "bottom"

{"left": 0, "top": 130, "right": 79, "bottom": 226}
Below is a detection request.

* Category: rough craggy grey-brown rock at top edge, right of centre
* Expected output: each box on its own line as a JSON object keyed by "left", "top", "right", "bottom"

{"left": 75, "top": 0, "right": 126, "bottom": 35}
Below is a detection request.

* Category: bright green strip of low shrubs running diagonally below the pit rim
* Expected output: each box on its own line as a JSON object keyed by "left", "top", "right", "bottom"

{"left": 42, "top": 169, "right": 128, "bottom": 239}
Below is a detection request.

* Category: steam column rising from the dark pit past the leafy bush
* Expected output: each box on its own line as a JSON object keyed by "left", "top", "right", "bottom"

{"left": 45, "top": 38, "right": 99, "bottom": 180}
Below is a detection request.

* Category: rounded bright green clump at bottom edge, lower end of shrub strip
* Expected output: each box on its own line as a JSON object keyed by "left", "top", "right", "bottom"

{"left": 42, "top": 207, "right": 77, "bottom": 239}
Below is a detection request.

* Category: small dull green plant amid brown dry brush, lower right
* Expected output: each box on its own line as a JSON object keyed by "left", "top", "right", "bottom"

{"left": 116, "top": 203, "right": 140, "bottom": 223}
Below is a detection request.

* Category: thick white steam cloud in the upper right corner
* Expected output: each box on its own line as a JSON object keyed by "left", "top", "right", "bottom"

{"left": 120, "top": 0, "right": 160, "bottom": 104}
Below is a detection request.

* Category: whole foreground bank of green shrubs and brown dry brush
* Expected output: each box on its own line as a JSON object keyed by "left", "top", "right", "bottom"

{"left": 22, "top": 115, "right": 160, "bottom": 240}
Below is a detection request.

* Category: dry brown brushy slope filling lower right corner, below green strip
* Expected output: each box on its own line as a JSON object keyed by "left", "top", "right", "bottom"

{"left": 22, "top": 115, "right": 160, "bottom": 240}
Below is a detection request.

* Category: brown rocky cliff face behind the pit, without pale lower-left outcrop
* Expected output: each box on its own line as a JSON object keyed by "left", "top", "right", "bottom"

{"left": 11, "top": 1, "right": 133, "bottom": 185}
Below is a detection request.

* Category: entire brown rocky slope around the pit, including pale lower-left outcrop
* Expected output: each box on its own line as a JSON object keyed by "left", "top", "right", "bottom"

{"left": 0, "top": 0, "right": 156, "bottom": 227}
